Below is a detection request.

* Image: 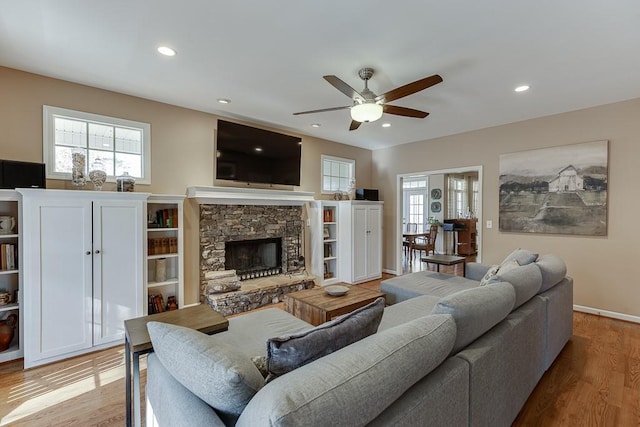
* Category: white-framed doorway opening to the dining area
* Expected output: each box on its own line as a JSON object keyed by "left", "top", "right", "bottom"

{"left": 396, "top": 166, "right": 482, "bottom": 275}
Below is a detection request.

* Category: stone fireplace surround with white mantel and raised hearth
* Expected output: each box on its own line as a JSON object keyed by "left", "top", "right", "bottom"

{"left": 187, "top": 187, "right": 314, "bottom": 315}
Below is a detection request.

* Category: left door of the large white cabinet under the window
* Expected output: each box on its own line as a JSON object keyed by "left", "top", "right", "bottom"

{"left": 24, "top": 200, "right": 93, "bottom": 367}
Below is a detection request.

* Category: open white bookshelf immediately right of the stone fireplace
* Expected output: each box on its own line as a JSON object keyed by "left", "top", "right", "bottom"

{"left": 307, "top": 200, "right": 340, "bottom": 286}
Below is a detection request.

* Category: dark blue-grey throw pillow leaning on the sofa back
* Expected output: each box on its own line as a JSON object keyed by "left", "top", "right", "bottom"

{"left": 267, "top": 298, "right": 384, "bottom": 381}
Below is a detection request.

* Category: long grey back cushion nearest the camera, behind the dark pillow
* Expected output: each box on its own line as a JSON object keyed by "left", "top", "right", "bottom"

{"left": 236, "top": 315, "right": 456, "bottom": 427}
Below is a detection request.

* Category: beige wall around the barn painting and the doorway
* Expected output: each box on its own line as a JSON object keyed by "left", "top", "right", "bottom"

{"left": 373, "top": 99, "right": 640, "bottom": 317}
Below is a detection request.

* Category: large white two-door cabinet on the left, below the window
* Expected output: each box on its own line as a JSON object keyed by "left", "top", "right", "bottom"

{"left": 17, "top": 189, "right": 149, "bottom": 368}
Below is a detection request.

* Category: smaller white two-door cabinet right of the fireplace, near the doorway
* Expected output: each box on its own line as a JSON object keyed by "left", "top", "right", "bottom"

{"left": 337, "top": 200, "right": 382, "bottom": 283}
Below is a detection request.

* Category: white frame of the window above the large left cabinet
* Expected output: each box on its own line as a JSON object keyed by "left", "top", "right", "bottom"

{"left": 42, "top": 105, "right": 151, "bottom": 184}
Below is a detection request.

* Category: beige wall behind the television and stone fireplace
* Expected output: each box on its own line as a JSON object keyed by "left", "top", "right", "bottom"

{"left": 0, "top": 67, "right": 372, "bottom": 303}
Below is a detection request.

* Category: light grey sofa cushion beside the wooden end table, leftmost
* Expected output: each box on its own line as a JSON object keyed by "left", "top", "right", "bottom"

{"left": 147, "top": 322, "right": 264, "bottom": 415}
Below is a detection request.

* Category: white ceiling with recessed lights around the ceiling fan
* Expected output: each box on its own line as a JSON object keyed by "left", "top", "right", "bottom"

{"left": 0, "top": 0, "right": 640, "bottom": 149}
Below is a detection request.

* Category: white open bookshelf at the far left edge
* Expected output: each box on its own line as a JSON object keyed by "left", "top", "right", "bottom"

{"left": 0, "top": 190, "right": 23, "bottom": 363}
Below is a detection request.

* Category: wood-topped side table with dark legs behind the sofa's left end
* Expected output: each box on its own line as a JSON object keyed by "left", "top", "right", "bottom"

{"left": 124, "top": 304, "right": 229, "bottom": 427}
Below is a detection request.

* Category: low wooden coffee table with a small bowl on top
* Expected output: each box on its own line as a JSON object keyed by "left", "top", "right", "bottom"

{"left": 284, "top": 283, "right": 384, "bottom": 326}
